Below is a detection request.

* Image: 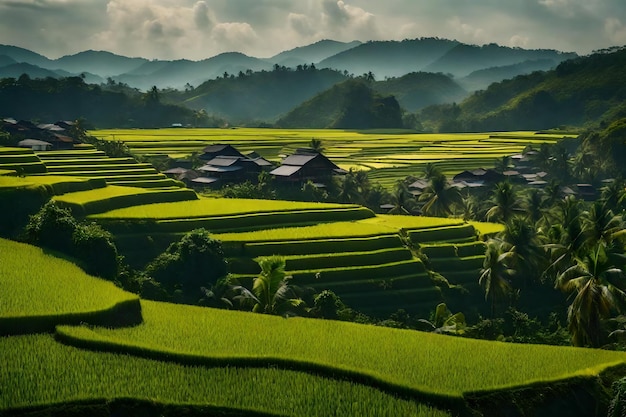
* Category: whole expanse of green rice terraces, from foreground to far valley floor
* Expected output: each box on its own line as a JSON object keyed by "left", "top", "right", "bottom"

{"left": 0, "top": 121, "right": 626, "bottom": 416}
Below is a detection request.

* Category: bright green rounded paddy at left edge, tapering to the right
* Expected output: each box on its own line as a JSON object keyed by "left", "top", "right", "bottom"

{"left": 0, "top": 239, "right": 138, "bottom": 335}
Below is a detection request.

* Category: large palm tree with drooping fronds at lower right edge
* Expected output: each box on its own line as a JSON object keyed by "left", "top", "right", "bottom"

{"left": 556, "top": 243, "right": 626, "bottom": 347}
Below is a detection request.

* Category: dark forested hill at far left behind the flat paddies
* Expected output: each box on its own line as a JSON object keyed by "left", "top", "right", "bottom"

{"left": 0, "top": 76, "right": 214, "bottom": 128}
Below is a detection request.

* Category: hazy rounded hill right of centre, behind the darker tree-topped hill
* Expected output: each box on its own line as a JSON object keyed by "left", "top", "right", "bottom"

{"left": 373, "top": 72, "right": 468, "bottom": 112}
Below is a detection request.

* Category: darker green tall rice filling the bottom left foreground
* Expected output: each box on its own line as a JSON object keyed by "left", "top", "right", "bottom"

{"left": 0, "top": 335, "right": 449, "bottom": 417}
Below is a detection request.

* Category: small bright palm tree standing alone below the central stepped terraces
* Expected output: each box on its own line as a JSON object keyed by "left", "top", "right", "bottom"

{"left": 252, "top": 255, "right": 304, "bottom": 314}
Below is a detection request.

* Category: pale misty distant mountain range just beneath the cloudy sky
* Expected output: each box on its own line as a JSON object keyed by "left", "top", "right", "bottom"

{"left": 0, "top": 38, "right": 576, "bottom": 90}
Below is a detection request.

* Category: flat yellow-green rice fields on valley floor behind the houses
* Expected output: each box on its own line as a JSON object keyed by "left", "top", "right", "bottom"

{"left": 90, "top": 128, "right": 565, "bottom": 187}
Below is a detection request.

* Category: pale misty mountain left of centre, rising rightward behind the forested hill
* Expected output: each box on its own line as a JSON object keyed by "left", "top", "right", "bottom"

{"left": 113, "top": 52, "right": 272, "bottom": 90}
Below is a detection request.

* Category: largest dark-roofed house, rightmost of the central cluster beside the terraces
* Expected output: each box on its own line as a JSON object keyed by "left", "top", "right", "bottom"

{"left": 270, "top": 151, "right": 346, "bottom": 184}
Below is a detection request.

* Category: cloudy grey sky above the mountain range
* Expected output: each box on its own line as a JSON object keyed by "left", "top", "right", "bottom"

{"left": 0, "top": 0, "right": 626, "bottom": 60}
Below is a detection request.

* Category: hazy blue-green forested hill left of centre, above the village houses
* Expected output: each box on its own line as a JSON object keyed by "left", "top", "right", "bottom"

{"left": 180, "top": 67, "right": 346, "bottom": 122}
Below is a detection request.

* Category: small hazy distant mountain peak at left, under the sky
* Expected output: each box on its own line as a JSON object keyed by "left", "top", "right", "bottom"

{"left": 51, "top": 50, "right": 148, "bottom": 77}
